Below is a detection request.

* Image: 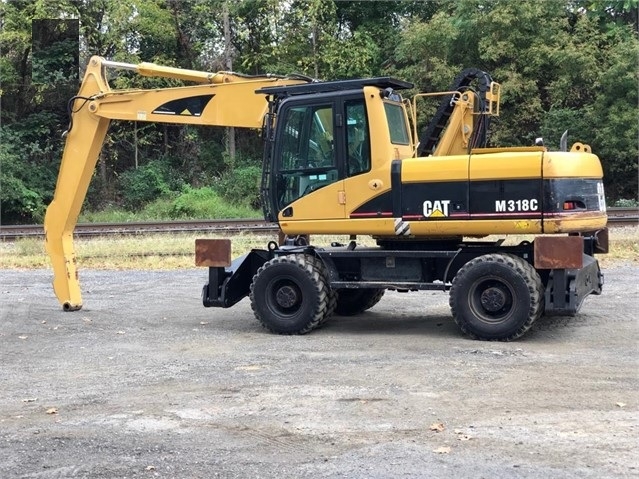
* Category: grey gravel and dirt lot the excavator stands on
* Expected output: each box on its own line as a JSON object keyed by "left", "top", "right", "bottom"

{"left": 0, "top": 265, "right": 639, "bottom": 479}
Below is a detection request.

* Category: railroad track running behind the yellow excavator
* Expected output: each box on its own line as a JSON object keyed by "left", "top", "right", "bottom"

{"left": 0, "top": 208, "right": 639, "bottom": 241}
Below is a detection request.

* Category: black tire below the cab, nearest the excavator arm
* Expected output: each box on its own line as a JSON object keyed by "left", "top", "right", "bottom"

{"left": 249, "top": 254, "right": 330, "bottom": 334}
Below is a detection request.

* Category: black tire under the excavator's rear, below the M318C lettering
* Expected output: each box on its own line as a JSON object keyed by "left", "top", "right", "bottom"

{"left": 450, "top": 254, "right": 544, "bottom": 341}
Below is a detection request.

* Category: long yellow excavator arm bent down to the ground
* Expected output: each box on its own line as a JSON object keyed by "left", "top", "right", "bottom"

{"left": 44, "top": 56, "right": 311, "bottom": 311}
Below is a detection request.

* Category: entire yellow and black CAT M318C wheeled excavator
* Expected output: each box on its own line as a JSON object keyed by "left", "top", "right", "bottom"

{"left": 45, "top": 57, "right": 608, "bottom": 340}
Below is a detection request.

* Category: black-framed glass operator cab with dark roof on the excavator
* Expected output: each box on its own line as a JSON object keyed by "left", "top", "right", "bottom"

{"left": 257, "top": 77, "right": 412, "bottom": 221}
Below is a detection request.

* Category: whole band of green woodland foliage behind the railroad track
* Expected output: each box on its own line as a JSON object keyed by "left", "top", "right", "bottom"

{"left": 0, "top": 0, "right": 639, "bottom": 222}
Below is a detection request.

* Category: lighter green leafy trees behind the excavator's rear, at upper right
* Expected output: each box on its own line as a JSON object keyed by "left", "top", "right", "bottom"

{"left": 396, "top": 0, "right": 637, "bottom": 199}
